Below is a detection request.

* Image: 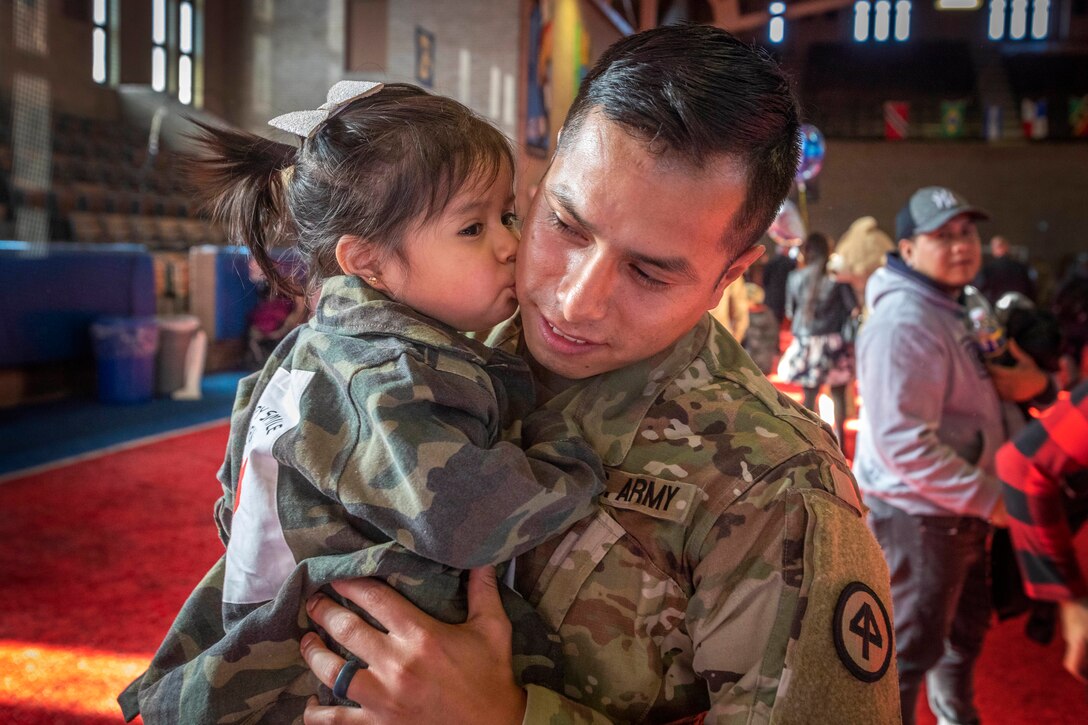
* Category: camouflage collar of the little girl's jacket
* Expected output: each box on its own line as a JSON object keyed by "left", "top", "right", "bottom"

{"left": 310, "top": 274, "right": 492, "bottom": 365}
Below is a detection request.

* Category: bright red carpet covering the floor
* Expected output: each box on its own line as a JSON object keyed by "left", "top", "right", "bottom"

{"left": 0, "top": 415, "right": 1088, "bottom": 725}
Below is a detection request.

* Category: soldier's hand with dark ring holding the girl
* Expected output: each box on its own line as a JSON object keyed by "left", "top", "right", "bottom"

{"left": 301, "top": 566, "right": 526, "bottom": 725}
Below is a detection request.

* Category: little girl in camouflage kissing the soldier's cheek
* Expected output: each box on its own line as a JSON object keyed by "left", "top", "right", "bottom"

{"left": 120, "top": 82, "right": 603, "bottom": 723}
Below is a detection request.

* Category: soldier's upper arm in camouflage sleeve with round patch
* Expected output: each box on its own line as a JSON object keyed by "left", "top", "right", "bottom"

{"left": 688, "top": 454, "right": 900, "bottom": 723}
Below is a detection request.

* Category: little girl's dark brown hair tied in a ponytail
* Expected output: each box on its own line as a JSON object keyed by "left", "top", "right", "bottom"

{"left": 188, "top": 84, "right": 514, "bottom": 294}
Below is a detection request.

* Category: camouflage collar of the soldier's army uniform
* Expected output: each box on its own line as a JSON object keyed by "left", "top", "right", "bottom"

{"left": 489, "top": 315, "right": 710, "bottom": 466}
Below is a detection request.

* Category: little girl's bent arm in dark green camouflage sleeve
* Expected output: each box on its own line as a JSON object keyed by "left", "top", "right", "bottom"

{"left": 308, "top": 356, "right": 603, "bottom": 568}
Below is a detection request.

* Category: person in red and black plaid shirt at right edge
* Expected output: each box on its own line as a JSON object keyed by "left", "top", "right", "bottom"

{"left": 997, "top": 381, "right": 1088, "bottom": 681}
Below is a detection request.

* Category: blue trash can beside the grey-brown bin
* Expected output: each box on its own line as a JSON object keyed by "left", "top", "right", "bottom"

{"left": 90, "top": 317, "right": 159, "bottom": 403}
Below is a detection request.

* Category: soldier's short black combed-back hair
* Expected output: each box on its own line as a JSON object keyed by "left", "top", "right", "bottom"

{"left": 558, "top": 24, "right": 801, "bottom": 255}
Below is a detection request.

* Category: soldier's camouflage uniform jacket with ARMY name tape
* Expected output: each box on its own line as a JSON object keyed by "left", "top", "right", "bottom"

{"left": 492, "top": 317, "right": 900, "bottom": 725}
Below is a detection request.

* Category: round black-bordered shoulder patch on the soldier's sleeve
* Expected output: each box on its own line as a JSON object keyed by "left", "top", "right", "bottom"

{"left": 831, "top": 581, "right": 894, "bottom": 683}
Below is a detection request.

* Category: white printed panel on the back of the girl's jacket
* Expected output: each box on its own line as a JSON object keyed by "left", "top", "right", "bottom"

{"left": 223, "top": 368, "right": 313, "bottom": 604}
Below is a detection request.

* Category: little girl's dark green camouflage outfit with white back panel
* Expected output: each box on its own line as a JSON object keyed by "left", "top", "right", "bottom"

{"left": 120, "top": 277, "right": 602, "bottom": 724}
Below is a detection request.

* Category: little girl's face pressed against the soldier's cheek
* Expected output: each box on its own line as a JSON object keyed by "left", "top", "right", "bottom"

{"left": 382, "top": 163, "right": 518, "bottom": 330}
